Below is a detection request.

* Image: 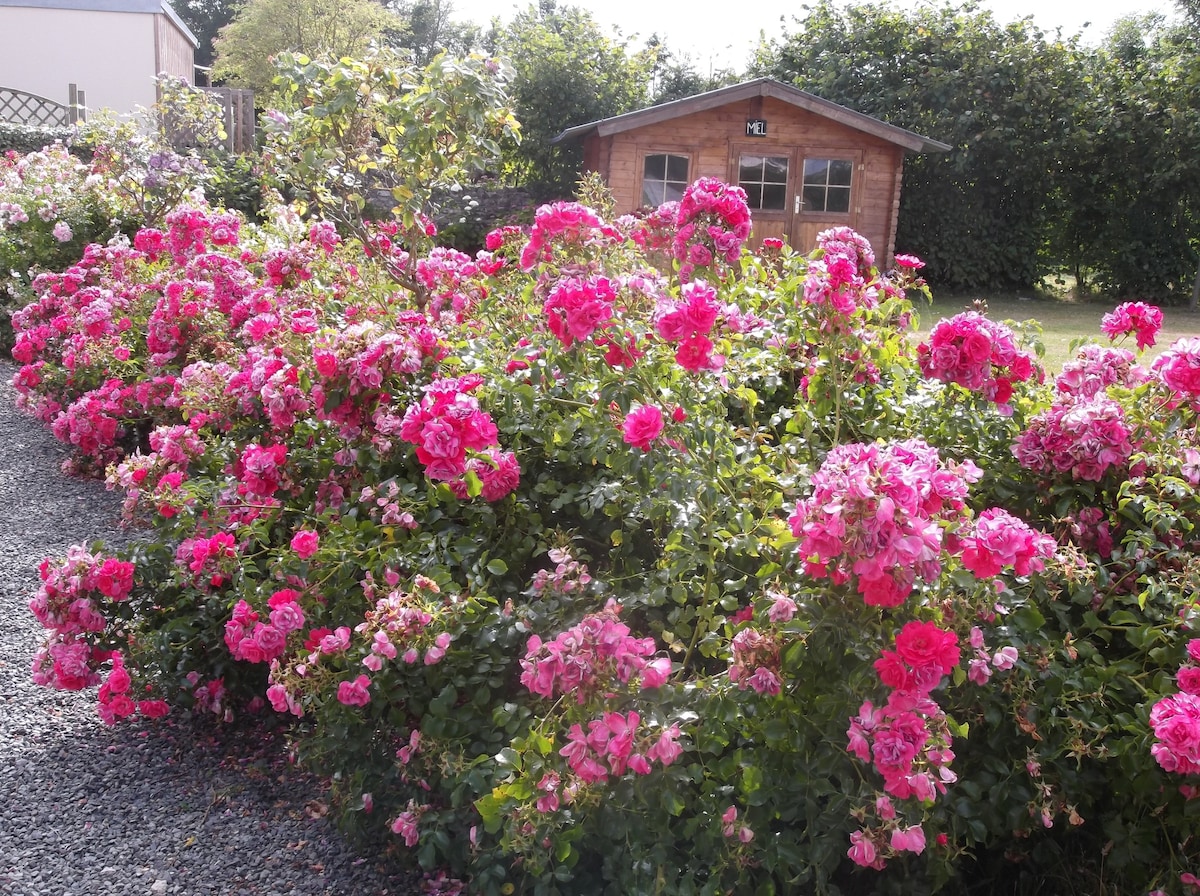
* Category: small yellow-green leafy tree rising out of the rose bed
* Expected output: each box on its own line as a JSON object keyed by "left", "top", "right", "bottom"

{"left": 264, "top": 49, "right": 517, "bottom": 294}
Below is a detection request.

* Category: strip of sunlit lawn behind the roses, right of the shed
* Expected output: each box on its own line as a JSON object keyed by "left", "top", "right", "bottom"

{"left": 917, "top": 295, "right": 1200, "bottom": 375}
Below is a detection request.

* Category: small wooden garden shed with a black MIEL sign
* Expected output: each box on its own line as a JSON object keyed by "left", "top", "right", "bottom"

{"left": 554, "top": 78, "right": 950, "bottom": 264}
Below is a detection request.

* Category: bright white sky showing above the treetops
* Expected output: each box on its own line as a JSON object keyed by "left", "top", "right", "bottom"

{"left": 451, "top": 0, "right": 1176, "bottom": 71}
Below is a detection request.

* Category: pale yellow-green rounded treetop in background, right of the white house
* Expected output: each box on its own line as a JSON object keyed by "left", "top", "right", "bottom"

{"left": 212, "top": 0, "right": 404, "bottom": 103}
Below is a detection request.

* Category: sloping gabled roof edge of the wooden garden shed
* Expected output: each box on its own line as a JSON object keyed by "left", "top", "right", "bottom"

{"left": 552, "top": 78, "right": 950, "bottom": 152}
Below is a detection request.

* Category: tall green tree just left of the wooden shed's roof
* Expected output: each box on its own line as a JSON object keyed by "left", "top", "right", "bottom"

{"left": 490, "top": 0, "right": 656, "bottom": 197}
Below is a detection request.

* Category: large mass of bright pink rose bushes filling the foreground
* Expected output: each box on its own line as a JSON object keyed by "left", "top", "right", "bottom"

{"left": 14, "top": 170, "right": 1200, "bottom": 896}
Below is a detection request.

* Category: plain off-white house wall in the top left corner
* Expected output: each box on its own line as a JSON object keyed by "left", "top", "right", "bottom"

{"left": 0, "top": 6, "right": 160, "bottom": 114}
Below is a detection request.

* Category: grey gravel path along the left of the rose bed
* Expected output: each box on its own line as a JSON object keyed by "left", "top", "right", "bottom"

{"left": 0, "top": 362, "right": 418, "bottom": 896}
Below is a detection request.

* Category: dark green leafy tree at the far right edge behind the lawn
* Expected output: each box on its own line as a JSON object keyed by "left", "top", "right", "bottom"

{"left": 1050, "top": 16, "right": 1200, "bottom": 301}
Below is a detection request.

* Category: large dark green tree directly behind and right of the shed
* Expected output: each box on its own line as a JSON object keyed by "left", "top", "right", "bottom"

{"left": 755, "top": 0, "right": 1085, "bottom": 290}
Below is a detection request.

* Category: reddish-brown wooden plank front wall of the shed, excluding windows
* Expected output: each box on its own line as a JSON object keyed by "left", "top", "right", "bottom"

{"left": 584, "top": 97, "right": 904, "bottom": 265}
